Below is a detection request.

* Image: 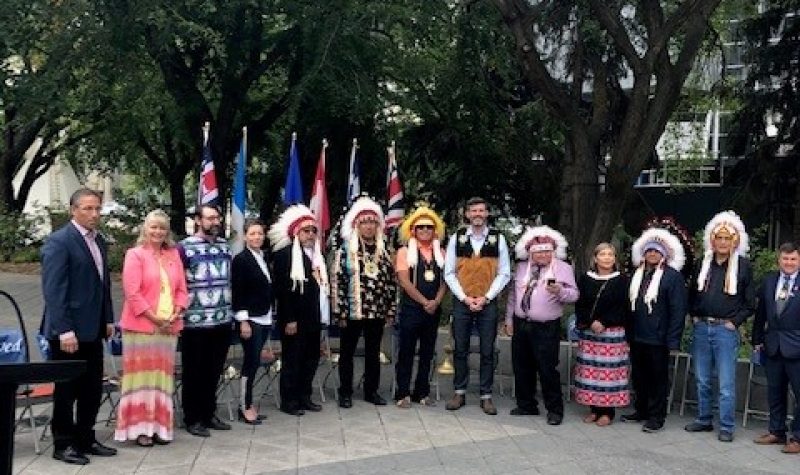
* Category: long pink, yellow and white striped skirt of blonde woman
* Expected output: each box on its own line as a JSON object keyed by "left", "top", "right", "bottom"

{"left": 114, "top": 332, "right": 177, "bottom": 441}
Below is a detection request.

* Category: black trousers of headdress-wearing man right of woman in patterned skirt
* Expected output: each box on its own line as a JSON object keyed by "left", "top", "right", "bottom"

{"left": 631, "top": 342, "right": 669, "bottom": 424}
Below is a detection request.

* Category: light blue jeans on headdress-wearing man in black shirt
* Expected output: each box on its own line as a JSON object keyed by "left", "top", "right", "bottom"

{"left": 692, "top": 320, "right": 739, "bottom": 433}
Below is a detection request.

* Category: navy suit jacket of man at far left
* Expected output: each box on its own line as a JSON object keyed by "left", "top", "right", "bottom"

{"left": 42, "top": 222, "right": 114, "bottom": 342}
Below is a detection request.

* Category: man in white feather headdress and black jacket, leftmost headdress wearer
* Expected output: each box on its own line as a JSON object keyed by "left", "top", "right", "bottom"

{"left": 269, "top": 205, "right": 330, "bottom": 416}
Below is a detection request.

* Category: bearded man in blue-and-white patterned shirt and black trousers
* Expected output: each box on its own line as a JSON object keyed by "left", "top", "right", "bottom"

{"left": 178, "top": 204, "right": 233, "bottom": 437}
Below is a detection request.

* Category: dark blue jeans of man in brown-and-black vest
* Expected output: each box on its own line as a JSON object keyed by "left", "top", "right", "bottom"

{"left": 453, "top": 299, "right": 497, "bottom": 397}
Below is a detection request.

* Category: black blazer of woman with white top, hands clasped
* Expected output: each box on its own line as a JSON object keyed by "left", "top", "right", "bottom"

{"left": 231, "top": 249, "right": 275, "bottom": 316}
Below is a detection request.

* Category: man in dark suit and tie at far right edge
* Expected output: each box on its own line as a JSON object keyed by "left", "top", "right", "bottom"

{"left": 753, "top": 243, "right": 800, "bottom": 454}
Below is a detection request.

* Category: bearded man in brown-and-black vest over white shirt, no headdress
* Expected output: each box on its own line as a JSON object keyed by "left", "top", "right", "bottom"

{"left": 444, "top": 198, "right": 511, "bottom": 416}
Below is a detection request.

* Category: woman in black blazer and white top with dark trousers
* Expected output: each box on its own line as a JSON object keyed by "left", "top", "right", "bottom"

{"left": 231, "top": 219, "right": 274, "bottom": 425}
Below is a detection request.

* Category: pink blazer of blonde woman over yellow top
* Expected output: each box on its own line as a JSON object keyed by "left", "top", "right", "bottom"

{"left": 119, "top": 246, "right": 188, "bottom": 333}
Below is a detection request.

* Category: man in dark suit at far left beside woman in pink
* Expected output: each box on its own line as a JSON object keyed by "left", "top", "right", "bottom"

{"left": 42, "top": 188, "right": 117, "bottom": 465}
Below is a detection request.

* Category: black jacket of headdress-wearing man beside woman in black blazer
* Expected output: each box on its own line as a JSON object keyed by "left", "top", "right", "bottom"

{"left": 274, "top": 246, "right": 320, "bottom": 332}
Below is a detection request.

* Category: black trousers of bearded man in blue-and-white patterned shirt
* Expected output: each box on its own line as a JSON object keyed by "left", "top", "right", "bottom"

{"left": 181, "top": 323, "right": 232, "bottom": 427}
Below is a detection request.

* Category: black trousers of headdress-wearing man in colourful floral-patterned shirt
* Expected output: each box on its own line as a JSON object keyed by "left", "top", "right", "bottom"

{"left": 339, "top": 318, "right": 386, "bottom": 397}
